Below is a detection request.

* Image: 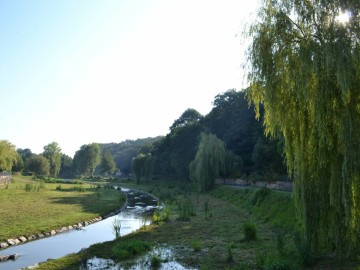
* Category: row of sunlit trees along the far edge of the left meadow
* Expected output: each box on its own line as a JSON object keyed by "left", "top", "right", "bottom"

{"left": 0, "top": 140, "right": 118, "bottom": 178}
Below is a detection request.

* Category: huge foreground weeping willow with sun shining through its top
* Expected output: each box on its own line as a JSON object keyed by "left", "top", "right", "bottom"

{"left": 248, "top": 0, "right": 360, "bottom": 257}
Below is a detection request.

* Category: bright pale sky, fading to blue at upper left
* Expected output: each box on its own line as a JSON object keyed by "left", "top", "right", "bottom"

{"left": 0, "top": 0, "right": 257, "bottom": 156}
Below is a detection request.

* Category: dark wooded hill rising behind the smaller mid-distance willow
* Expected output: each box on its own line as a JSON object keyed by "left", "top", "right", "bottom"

{"left": 101, "top": 89, "right": 286, "bottom": 181}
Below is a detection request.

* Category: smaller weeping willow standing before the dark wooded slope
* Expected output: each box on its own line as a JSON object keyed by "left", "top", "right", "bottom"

{"left": 189, "top": 133, "right": 226, "bottom": 192}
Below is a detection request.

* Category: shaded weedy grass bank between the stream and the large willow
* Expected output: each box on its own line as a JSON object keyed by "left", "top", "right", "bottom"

{"left": 14, "top": 180, "right": 357, "bottom": 270}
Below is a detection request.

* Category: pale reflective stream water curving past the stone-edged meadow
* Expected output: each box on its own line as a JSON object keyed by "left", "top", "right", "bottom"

{"left": 0, "top": 189, "right": 158, "bottom": 270}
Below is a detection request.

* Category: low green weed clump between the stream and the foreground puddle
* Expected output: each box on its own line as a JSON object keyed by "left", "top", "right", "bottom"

{"left": 112, "top": 239, "right": 150, "bottom": 261}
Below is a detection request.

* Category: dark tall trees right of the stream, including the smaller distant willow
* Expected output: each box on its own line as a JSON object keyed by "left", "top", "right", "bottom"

{"left": 132, "top": 89, "right": 286, "bottom": 187}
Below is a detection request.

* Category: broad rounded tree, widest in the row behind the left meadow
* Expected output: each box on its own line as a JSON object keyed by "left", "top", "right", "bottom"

{"left": 74, "top": 143, "right": 101, "bottom": 176}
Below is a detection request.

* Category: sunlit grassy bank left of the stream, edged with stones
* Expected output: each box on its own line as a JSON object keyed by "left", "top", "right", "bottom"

{"left": 0, "top": 176, "right": 123, "bottom": 241}
